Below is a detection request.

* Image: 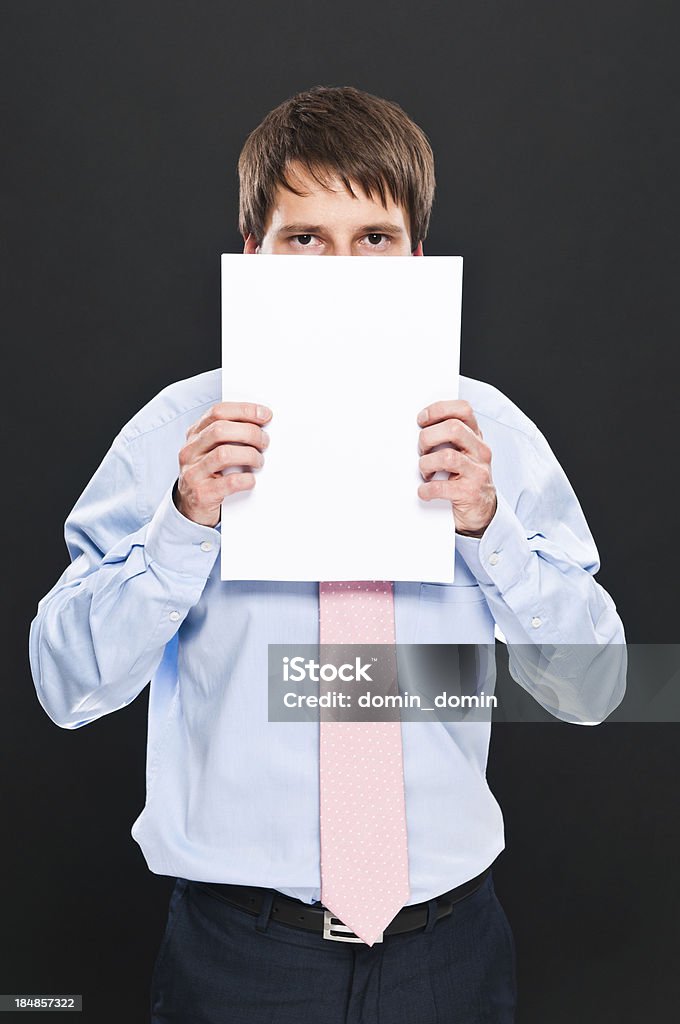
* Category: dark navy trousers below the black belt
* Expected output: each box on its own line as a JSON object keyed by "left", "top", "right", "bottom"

{"left": 151, "top": 872, "right": 516, "bottom": 1024}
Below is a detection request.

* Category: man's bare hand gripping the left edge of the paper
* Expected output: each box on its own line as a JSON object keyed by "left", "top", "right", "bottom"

{"left": 172, "top": 401, "right": 271, "bottom": 526}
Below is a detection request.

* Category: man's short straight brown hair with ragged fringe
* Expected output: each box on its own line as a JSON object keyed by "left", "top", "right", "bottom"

{"left": 239, "top": 85, "right": 434, "bottom": 250}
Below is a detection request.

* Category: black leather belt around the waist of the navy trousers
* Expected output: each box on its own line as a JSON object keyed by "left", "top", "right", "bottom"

{"left": 194, "top": 867, "right": 491, "bottom": 942}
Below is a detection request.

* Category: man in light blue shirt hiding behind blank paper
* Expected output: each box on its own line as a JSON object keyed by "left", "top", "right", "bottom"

{"left": 31, "top": 88, "right": 624, "bottom": 1024}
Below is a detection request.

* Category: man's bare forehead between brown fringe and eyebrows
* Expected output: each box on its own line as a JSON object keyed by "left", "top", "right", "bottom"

{"left": 266, "top": 164, "right": 408, "bottom": 230}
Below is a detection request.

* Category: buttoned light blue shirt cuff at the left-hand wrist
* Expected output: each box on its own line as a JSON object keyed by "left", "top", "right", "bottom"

{"left": 144, "top": 481, "right": 221, "bottom": 580}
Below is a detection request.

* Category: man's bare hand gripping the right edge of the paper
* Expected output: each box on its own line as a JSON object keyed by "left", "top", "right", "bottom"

{"left": 418, "top": 399, "right": 497, "bottom": 537}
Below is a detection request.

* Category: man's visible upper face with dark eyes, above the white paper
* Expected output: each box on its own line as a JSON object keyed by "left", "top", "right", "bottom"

{"left": 244, "top": 164, "right": 423, "bottom": 256}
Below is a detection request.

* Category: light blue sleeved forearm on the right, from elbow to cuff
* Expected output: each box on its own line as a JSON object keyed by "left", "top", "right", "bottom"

{"left": 457, "top": 498, "right": 627, "bottom": 723}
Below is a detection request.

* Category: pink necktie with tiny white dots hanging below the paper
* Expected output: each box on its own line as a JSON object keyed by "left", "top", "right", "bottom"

{"left": 318, "top": 581, "right": 410, "bottom": 946}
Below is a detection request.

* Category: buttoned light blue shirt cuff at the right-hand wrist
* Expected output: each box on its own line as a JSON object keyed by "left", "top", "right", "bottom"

{"left": 456, "top": 492, "right": 533, "bottom": 594}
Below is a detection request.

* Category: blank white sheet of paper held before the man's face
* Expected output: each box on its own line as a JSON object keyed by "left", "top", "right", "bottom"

{"left": 221, "top": 253, "right": 463, "bottom": 583}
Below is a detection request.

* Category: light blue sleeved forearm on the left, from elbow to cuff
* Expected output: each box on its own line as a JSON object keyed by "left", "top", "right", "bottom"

{"left": 30, "top": 493, "right": 220, "bottom": 728}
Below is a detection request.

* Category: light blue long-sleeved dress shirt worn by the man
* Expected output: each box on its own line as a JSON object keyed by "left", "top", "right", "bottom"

{"left": 30, "top": 370, "right": 625, "bottom": 903}
